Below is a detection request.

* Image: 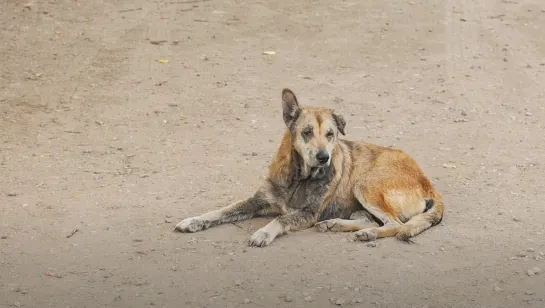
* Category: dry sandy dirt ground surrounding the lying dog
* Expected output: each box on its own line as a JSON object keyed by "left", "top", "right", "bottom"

{"left": 0, "top": 0, "right": 545, "bottom": 308}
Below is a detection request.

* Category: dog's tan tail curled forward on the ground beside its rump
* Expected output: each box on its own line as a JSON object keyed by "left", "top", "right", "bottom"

{"left": 396, "top": 193, "right": 443, "bottom": 242}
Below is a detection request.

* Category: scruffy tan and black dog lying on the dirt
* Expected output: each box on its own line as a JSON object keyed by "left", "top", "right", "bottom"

{"left": 175, "top": 89, "right": 443, "bottom": 247}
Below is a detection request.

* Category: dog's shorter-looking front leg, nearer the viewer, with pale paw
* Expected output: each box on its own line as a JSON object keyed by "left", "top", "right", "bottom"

{"left": 249, "top": 209, "right": 316, "bottom": 247}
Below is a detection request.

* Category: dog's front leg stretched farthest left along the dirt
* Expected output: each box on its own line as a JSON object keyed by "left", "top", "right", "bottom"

{"left": 175, "top": 193, "right": 270, "bottom": 232}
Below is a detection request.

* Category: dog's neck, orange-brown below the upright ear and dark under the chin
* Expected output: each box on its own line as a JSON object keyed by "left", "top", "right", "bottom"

{"left": 269, "top": 130, "right": 332, "bottom": 186}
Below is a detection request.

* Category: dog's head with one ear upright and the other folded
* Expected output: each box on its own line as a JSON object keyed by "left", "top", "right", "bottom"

{"left": 282, "top": 89, "right": 346, "bottom": 167}
